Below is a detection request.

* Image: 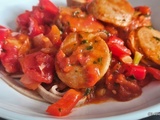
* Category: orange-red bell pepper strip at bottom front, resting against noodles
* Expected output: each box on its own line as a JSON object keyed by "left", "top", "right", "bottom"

{"left": 46, "top": 89, "right": 83, "bottom": 116}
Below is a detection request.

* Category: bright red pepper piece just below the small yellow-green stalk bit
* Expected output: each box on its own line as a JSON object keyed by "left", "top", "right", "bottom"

{"left": 124, "top": 64, "right": 146, "bottom": 80}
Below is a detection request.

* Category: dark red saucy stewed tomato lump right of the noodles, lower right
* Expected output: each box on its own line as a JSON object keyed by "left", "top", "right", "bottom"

{"left": 106, "top": 72, "right": 142, "bottom": 101}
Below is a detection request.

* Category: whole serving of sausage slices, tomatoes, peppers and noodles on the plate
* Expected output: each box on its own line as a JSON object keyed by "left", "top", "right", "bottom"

{"left": 0, "top": 0, "right": 160, "bottom": 116}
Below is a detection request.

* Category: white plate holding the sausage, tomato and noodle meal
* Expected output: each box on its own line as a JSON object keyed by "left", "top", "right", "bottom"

{"left": 0, "top": 0, "right": 160, "bottom": 120}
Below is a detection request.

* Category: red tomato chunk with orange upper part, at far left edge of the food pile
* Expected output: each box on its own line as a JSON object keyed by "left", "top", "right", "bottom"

{"left": 1, "top": 32, "right": 31, "bottom": 73}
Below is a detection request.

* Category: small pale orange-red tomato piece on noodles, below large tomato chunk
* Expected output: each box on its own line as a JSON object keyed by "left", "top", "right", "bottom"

{"left": 20, "top": 74, "right": 41, "bottom": 90}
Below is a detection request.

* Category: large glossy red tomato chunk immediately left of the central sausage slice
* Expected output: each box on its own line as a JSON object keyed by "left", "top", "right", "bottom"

{"left": 21, "top": 52, "right": 54, "bottom": 83}
